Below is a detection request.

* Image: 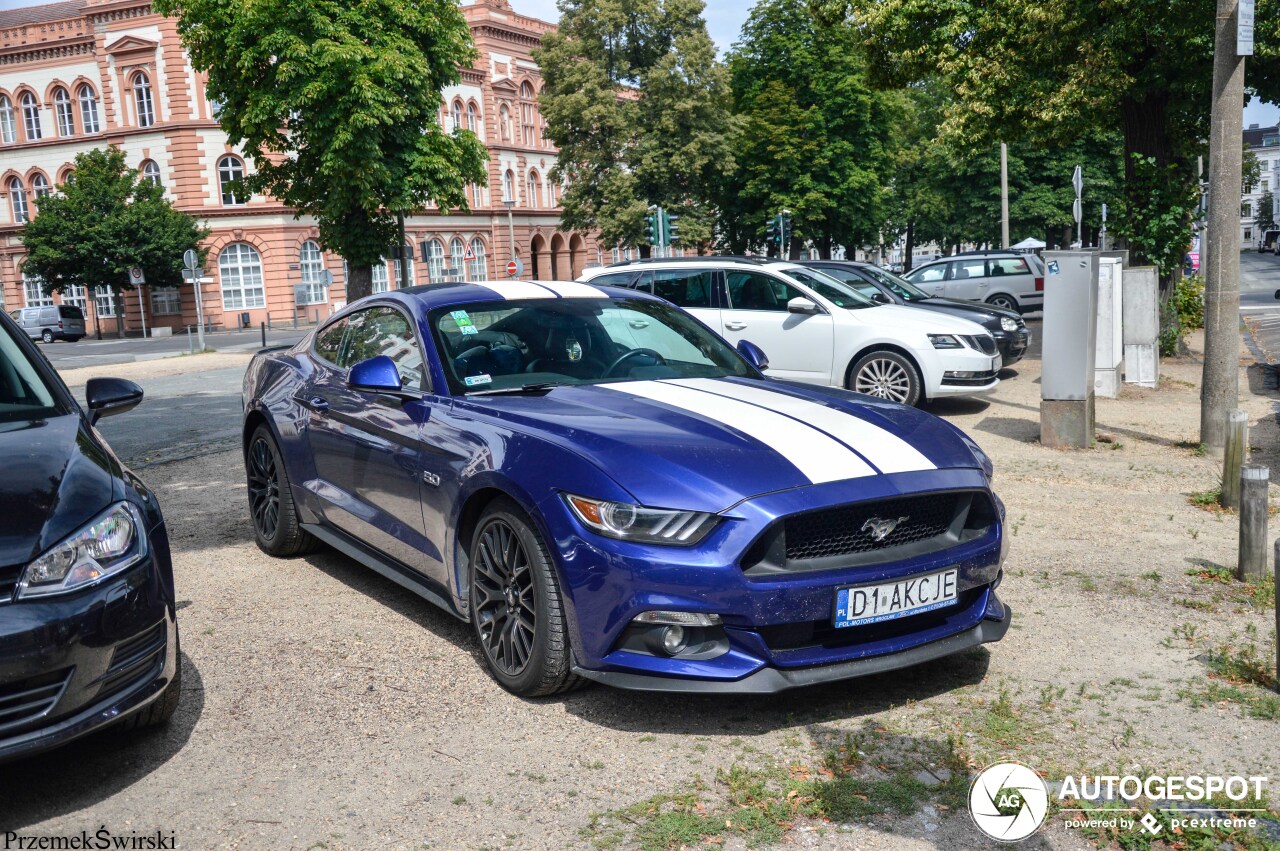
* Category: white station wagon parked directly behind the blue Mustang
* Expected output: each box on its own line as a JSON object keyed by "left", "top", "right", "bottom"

{"left": 582, "top": 257, "right": 1001, "bottom": 404}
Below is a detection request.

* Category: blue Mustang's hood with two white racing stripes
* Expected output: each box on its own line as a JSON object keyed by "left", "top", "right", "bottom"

{"left": 458, "top": 379, "right": 979, "bottom": 512}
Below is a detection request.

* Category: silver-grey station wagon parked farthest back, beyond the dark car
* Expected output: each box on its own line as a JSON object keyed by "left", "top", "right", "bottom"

{"left": 902, "top": 251, "right": 1044, "bottom": 314}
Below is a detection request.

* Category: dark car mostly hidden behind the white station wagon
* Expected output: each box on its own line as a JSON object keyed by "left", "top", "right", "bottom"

{"left": 804, "top": 260, "right": 1032, "bottom": 366}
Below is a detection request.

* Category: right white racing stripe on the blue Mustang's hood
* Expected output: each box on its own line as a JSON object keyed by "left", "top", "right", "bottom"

{"left": 669, "top": 379, "right": 937, "bottom": 472}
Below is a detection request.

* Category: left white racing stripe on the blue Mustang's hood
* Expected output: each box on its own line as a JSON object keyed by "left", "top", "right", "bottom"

{"left": 599, "top": 381, "right": 876, "bottom": 485}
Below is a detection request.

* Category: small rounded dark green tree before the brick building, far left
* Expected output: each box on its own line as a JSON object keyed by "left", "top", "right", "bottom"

{"left": 22, "top": 146, "right": 209, "bottom": 326}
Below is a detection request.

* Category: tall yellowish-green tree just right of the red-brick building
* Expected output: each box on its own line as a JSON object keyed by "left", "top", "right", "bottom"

{"left": 534, "top": 0, "right": 732, "bottom": 252}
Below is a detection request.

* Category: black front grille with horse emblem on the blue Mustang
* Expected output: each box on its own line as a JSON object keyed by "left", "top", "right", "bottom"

{"left": 742, "top": 490, "right": 996, "bottom": 576}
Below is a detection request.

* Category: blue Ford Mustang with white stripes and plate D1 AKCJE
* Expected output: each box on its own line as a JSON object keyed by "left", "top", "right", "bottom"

{"left": 243, "top": 282, "right": 1010, "bottom": 696}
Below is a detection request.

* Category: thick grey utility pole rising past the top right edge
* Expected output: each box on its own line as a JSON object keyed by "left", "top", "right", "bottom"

{"left": 1201, "top": 0, "right": 1253, "bottom": 452}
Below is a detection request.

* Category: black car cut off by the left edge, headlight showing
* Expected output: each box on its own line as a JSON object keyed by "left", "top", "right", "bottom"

{"left": 0, "top": 308, "right": 182, "bottom": 761}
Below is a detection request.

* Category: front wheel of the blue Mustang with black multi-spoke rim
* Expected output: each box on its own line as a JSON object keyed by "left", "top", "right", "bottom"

{"left": 467, "top": 498, "right": 581, "bottom": 697}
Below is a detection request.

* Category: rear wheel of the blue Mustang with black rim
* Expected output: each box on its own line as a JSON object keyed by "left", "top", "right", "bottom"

{"left": 244, "top": 424, "right": 316, "bottom": 557}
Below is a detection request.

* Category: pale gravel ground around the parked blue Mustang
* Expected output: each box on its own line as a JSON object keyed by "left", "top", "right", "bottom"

{"left": 0, "top": 340, "right": 1280, "bottom": 850}
